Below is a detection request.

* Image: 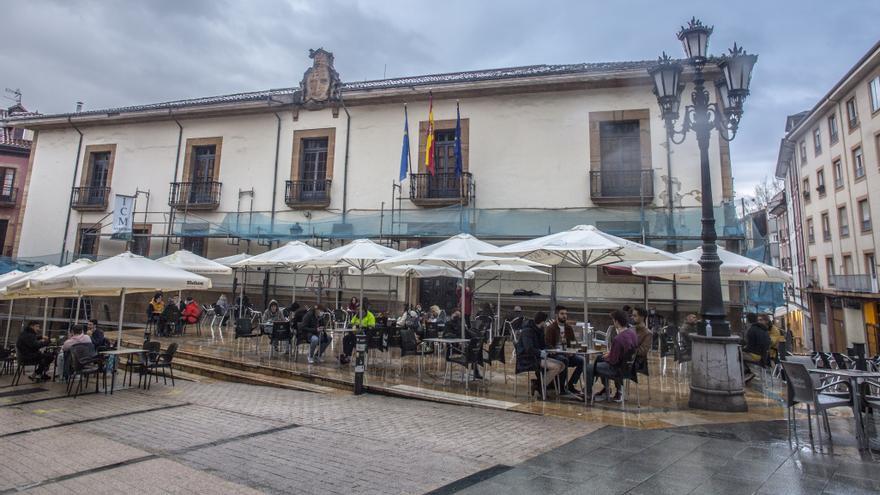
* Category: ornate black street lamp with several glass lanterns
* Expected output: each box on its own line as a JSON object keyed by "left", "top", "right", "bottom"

{"left": 648, "top": 18, "right": 758, "bottom": 410}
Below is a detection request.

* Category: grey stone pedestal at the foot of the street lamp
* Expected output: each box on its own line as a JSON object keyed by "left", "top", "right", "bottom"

{"left": 688, "top": 334, "right": 749, "bottom": 412}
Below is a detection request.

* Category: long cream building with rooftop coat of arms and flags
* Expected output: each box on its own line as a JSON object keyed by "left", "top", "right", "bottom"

{"left": 6, "top": 50, "right": 741, "bottom": 322}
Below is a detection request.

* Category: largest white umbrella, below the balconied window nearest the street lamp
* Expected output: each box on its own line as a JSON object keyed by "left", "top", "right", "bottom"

{"left": 485, "top": 225, "right": 675, "bottom": 335}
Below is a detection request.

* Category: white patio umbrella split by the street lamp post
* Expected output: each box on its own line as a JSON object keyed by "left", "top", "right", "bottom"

{"left": 632, "top": 246, "right": 792, "bottom": 283}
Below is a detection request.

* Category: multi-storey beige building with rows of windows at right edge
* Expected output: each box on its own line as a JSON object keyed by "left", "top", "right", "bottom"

{"left": 776, "top": 43, "right": 880, "bottom": 355}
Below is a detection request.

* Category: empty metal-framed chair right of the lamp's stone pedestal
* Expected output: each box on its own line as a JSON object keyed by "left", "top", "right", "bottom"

{"left": 782, "top": 361, "right": 859, "bottom": 448}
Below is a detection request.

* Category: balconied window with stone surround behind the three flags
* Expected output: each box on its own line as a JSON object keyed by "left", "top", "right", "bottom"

{"left": 409, "top": 118, "right": 474, "bottom": 207}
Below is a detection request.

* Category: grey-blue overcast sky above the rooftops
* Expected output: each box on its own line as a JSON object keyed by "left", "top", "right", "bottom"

{"left": 0, "top": 0, "right": 880, "bottom": 195}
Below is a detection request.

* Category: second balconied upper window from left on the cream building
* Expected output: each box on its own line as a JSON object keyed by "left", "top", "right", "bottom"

{"left": 168, "top": 137, "right": 223, "bottom": 210}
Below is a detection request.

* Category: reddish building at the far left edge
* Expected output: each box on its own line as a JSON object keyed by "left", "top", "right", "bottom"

{"left": 0, "top": 104, "right": 33, "bottom": 256}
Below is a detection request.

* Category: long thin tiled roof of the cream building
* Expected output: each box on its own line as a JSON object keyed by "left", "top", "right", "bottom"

{"left": 3, "top": 61, "right": 655, "bottom": 122}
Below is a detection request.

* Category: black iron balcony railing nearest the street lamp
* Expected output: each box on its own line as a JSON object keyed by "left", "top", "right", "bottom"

{"left": 590, "top": 170, "right": 654, "bottom": 205}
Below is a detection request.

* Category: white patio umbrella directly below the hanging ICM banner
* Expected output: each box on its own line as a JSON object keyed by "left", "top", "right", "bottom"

{"left": 47, "top": 252, "right": 211, "bottom": 346}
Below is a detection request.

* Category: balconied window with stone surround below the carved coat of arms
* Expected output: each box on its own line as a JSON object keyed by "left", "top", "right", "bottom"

{"left": 284, "top": 128, "right": 336, "bottom": 209}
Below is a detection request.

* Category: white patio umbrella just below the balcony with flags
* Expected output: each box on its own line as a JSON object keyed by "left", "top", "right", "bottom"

{"left": 379, "top": 234, "right": 527, "bottom": 338}
